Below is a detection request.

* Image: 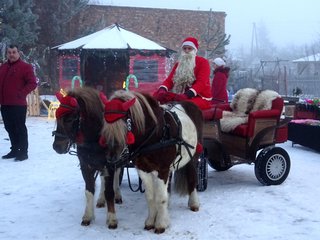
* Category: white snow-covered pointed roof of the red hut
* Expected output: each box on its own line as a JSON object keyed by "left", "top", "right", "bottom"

{"left": 54, "top": 24, "right": 166, "bottom": 50}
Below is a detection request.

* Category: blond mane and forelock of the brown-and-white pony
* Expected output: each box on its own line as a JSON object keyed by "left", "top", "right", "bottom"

{"left": 102, "top": 90, "right": 160, "bottom": 147}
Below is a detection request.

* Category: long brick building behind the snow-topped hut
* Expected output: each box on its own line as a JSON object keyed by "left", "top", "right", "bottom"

{"left": 68, "top": 5, "right": 226, "bottom": 54}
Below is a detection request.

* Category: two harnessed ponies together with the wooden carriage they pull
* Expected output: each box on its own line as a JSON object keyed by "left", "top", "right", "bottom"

{"left": 53, "top": 88, "right": 290, "bottom": 233}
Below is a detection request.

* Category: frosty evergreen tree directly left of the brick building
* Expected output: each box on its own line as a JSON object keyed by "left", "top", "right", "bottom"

{"left": 30, "top": 0, "right": 89, "bottom": 91}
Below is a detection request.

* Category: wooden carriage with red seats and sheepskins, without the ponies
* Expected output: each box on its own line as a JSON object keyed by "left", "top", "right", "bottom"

{"left": 197, "top": 88, "right": 290, "bottom": 191}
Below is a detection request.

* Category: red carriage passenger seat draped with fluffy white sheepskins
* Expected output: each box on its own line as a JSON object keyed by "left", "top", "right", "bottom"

{"left": 203, "top": 88, "right": 287, "bottom": 142}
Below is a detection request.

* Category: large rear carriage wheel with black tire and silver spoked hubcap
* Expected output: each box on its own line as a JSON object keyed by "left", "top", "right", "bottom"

{"left": 254, "top": 147, "right": 291, "bottom": 186}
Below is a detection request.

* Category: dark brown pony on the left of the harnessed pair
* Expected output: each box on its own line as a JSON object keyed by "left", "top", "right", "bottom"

{"left": 53, "top": 87, "right": 122, "bottom": 228}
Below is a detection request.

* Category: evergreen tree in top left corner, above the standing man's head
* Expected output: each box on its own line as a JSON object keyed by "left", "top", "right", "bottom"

{"left": 0, "top": 0, "right": 39, "bottom": 52}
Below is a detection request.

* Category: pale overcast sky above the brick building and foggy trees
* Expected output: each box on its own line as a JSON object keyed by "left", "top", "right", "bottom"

{"left": 92, "top": 0, "right": 320, "bottom": 48}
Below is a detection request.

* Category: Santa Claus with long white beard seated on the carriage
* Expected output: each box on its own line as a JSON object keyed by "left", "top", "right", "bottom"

{"left": 154, "top": 37, "right": 212, "bottom": 109}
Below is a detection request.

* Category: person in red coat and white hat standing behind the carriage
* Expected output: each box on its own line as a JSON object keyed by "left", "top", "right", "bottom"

{"left": 211, "top": 58, "right": 230, "bottom": 104}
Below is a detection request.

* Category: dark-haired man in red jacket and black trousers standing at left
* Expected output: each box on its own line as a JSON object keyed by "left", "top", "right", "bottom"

{"left": 0, "top": 45, "right": 37, "bottom": 161}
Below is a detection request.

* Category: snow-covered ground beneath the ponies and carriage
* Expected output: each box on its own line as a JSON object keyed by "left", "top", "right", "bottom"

{"left": 0, "top": 117, "right": 320, "bottom": 240}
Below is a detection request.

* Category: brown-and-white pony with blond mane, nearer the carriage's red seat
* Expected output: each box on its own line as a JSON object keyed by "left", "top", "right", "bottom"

{"left": 101, "top": 90, "right": 203, "bottom": 233}
